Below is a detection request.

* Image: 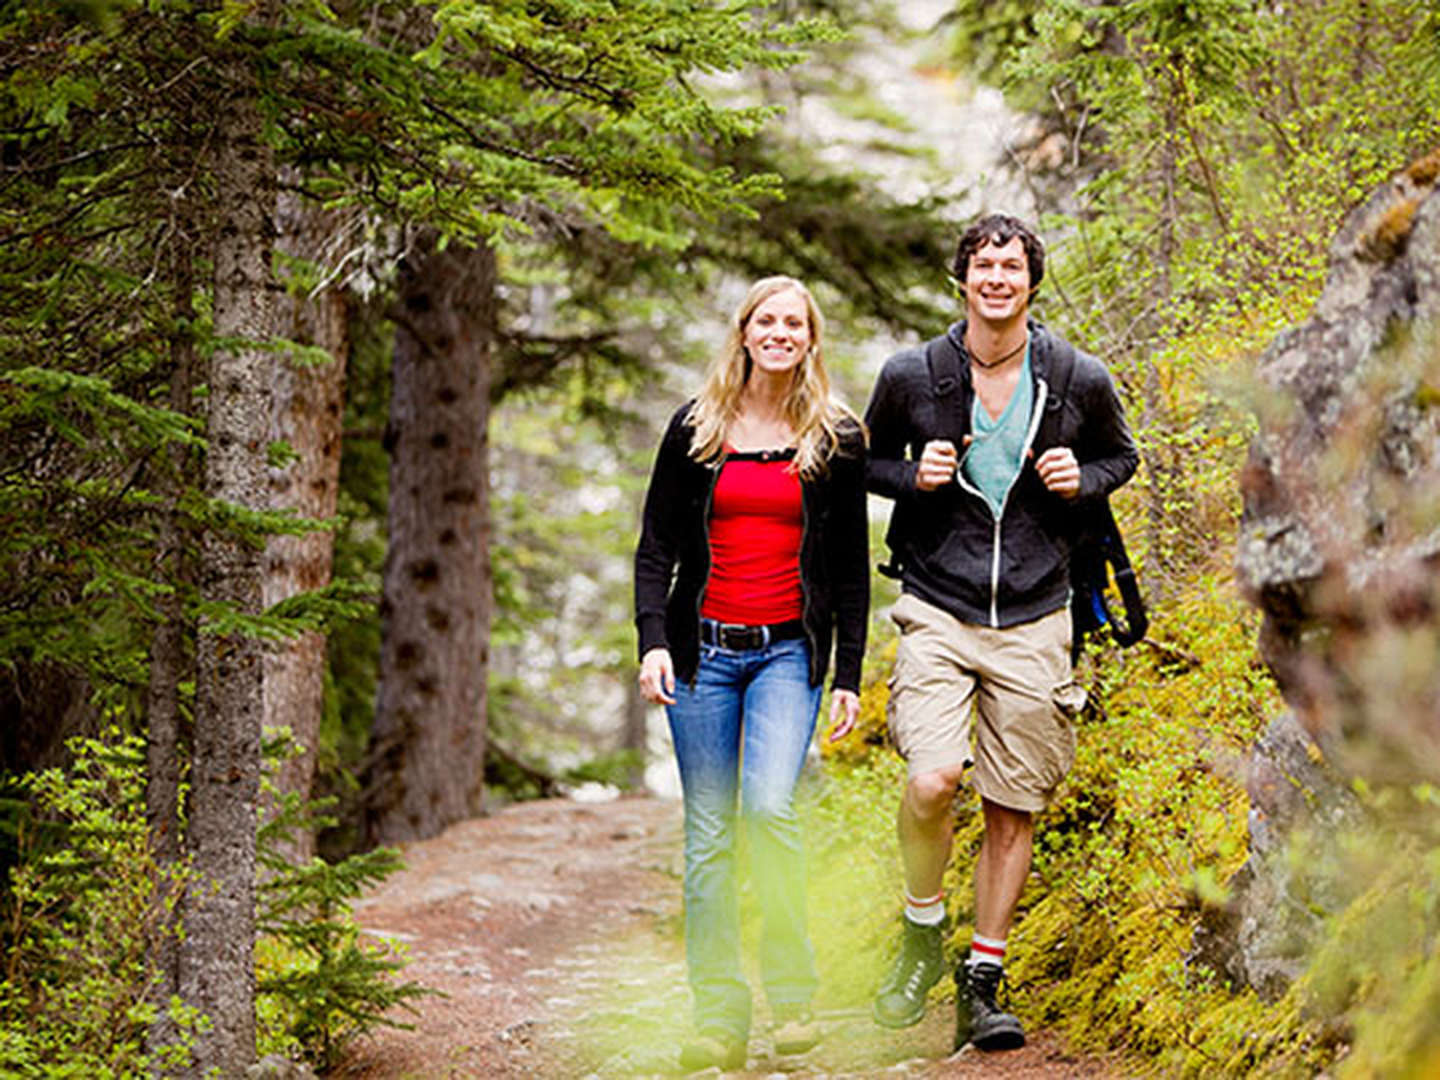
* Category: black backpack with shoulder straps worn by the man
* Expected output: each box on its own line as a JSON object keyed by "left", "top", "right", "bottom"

{"left": 880, "top": 334, "right": 1149, "bottom": 660}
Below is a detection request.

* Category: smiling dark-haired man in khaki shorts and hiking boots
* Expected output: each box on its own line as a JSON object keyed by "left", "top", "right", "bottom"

{"left": 865, "top": 215, "right": 1139, "bottom": 1050}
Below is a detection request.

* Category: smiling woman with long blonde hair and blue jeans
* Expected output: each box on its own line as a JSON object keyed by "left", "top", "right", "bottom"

{"left": 635, "top": 276, "right": 870, "bottom": 1070}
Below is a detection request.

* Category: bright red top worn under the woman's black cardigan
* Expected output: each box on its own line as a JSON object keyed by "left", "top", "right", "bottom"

{"left": 700, "top": 454, "right": 805, "bottom": 626}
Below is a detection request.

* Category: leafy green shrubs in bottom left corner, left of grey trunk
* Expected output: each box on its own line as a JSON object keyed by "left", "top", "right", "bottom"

{"left": 0, "top": 729, "right": 197, "bottom": 1077}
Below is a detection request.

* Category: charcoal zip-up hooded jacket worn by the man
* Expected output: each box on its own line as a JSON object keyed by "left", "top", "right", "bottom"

{"left": 865, "top": 320, "right": 1139, "bottom": 626}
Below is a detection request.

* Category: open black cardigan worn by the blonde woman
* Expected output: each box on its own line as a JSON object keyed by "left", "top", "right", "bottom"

{"left": 635, "top": 402, "right": 870, "bottom": 693}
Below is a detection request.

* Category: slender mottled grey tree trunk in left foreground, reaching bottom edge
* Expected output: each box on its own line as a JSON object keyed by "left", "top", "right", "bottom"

{"left": 180, "top": 48, "right": 275, "bottom": 1077}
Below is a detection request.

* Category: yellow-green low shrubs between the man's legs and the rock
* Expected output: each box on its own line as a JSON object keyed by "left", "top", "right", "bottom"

{"left": 1012, "top": 576, "right": 1286, "bottom": 1074}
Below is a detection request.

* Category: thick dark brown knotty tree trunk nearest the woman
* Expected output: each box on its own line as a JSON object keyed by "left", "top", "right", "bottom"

{"left": 364, "top": 239, "right": 495, "bottom": 844}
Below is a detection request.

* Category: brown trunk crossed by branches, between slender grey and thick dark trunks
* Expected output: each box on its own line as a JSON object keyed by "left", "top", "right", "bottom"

{"left": 264, "top": 185, "right": 348, "bottom": 861}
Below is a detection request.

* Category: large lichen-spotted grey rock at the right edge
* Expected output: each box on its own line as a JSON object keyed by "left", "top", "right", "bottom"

{"left": 1215, "top": 150, "right": 1440, "bottom": 998}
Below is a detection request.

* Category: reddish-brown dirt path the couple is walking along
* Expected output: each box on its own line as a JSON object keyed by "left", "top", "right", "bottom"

{"left": 342, "top": 798, "right": 1125, "bottom": 1080}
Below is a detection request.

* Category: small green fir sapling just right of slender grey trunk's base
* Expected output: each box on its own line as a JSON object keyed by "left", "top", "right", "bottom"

{"left": 256, "top": 736, "right": 436, "bottom": 1070}
